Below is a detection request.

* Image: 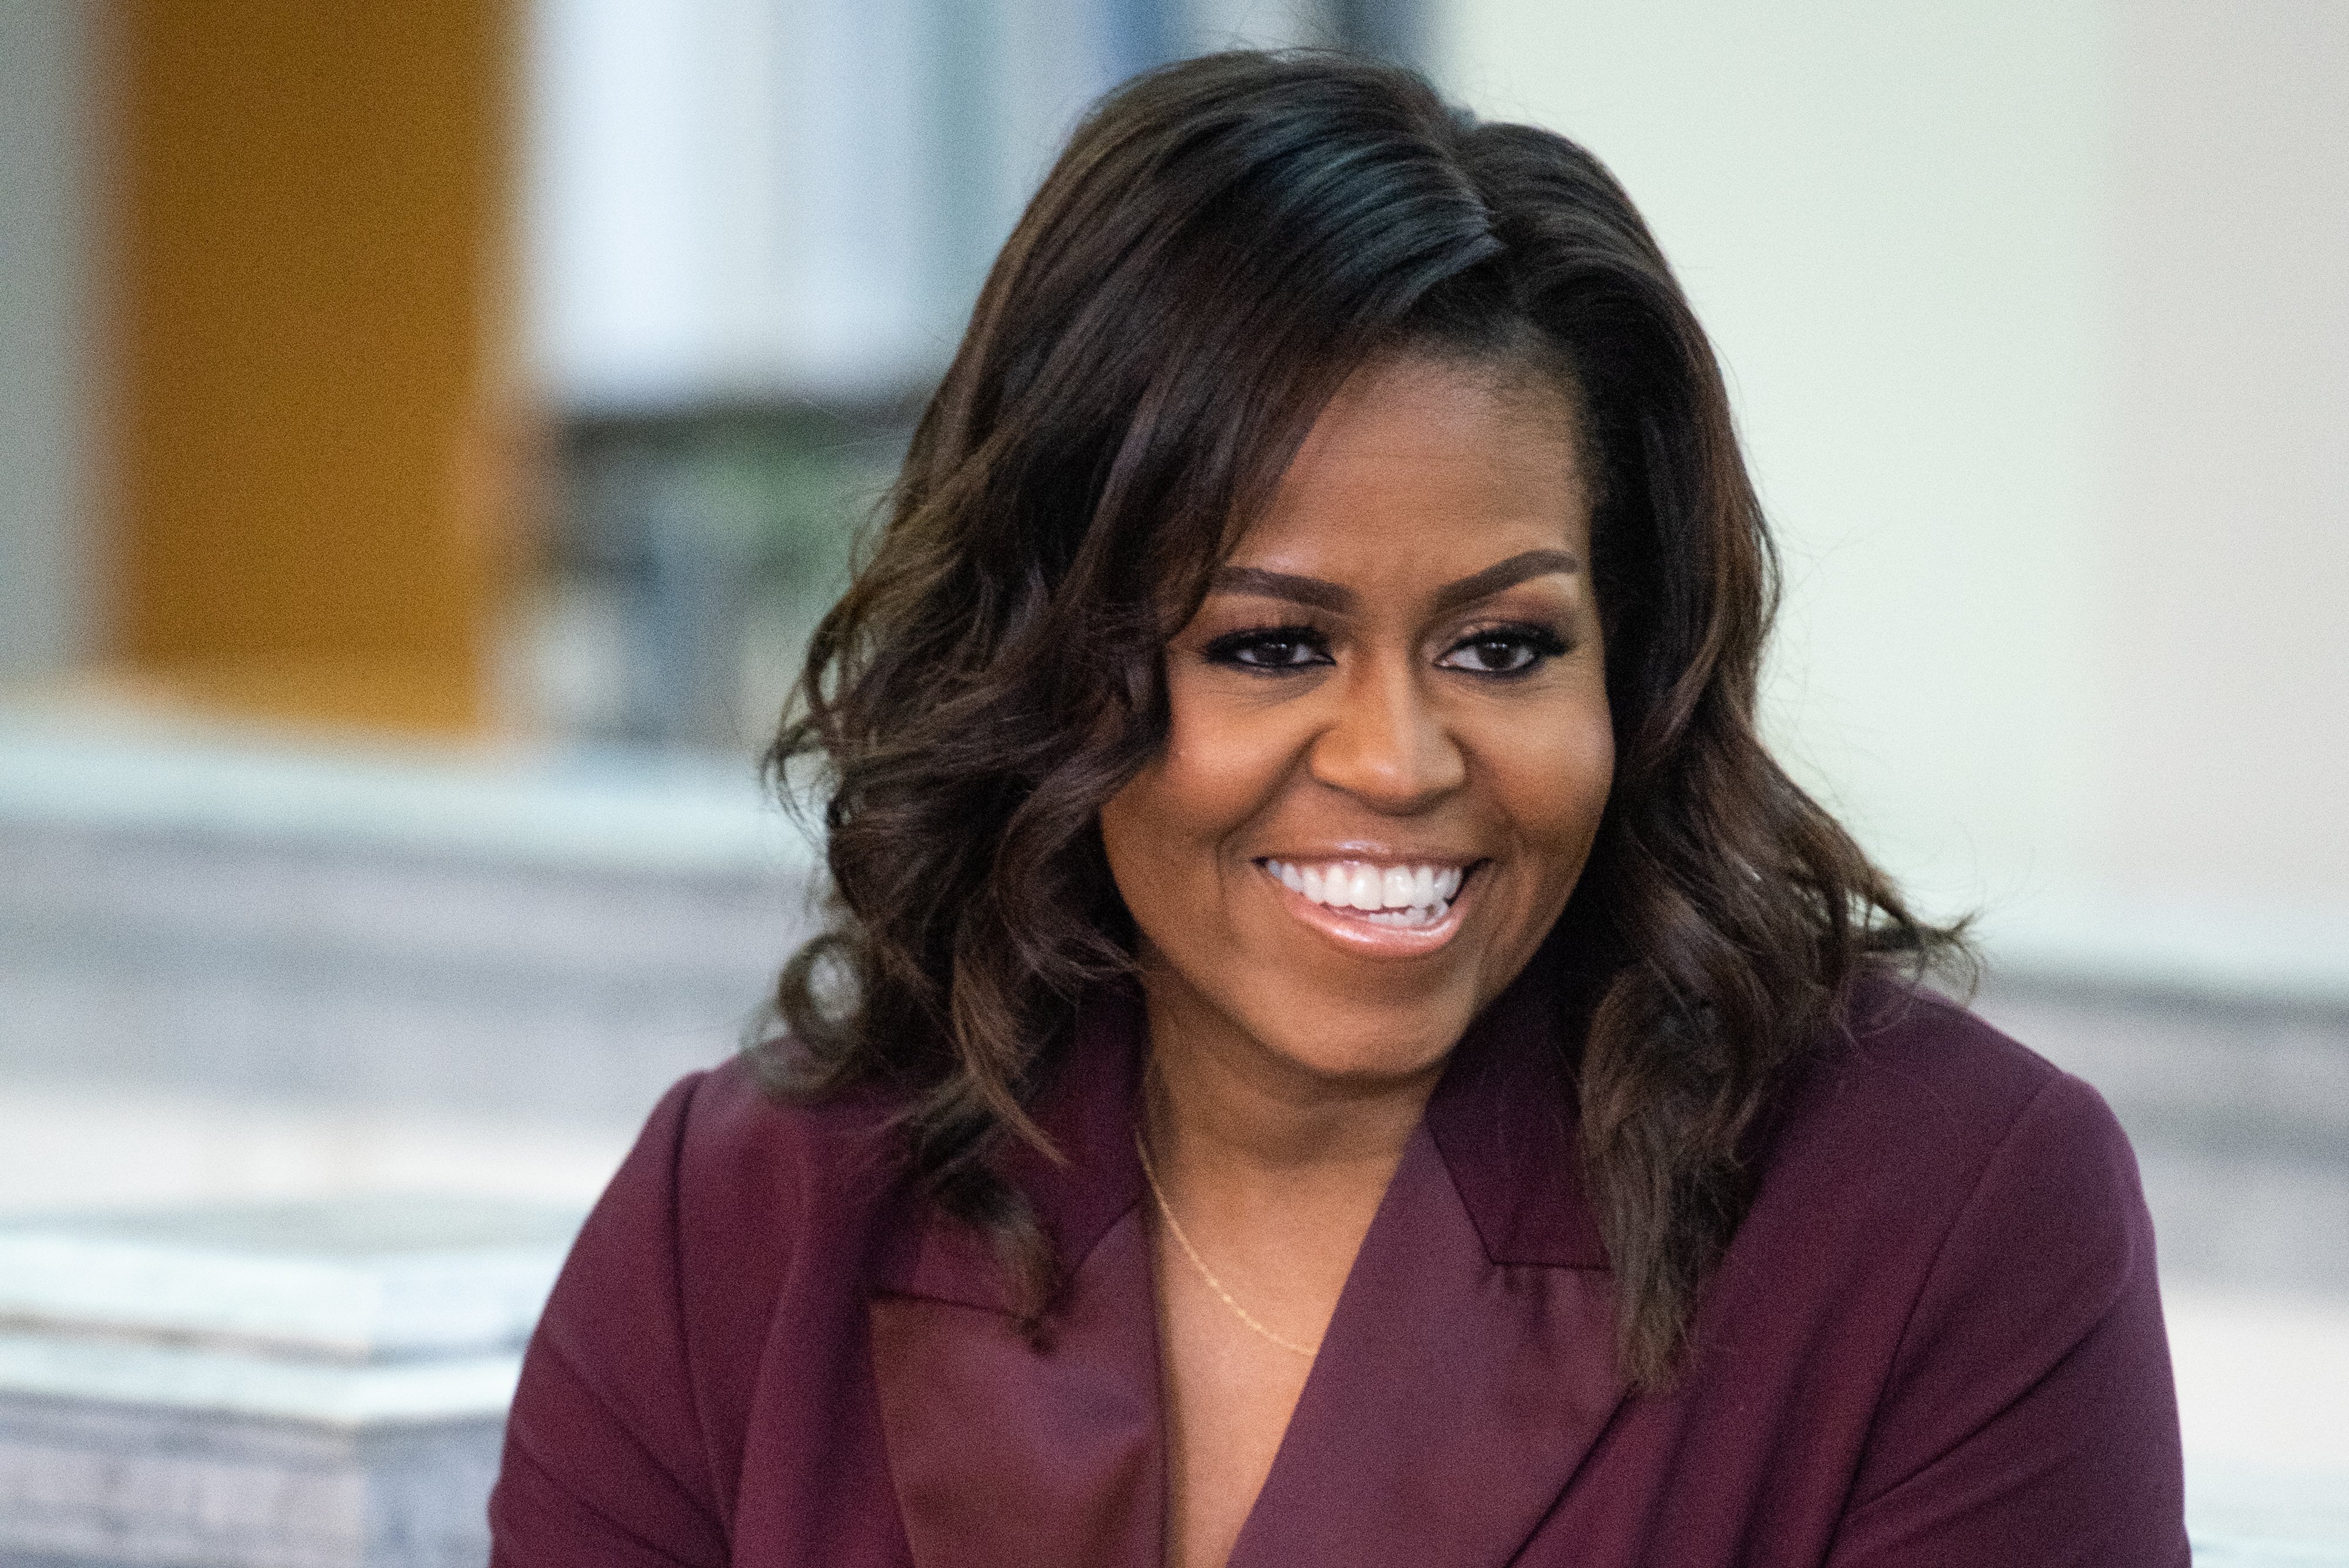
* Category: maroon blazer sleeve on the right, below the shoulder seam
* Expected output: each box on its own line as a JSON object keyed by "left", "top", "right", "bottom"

{"left": 1828, "top": 1075, "right": 2189, "bottom": 1568}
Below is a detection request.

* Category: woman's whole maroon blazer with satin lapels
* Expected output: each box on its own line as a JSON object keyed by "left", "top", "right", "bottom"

{"left": 491, "top": 971, "right": 2187, "bottom": 1568}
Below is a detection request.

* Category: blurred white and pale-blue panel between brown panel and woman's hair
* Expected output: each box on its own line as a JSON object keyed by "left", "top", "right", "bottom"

{"left": 524, "top": 0, "right": 1353, "bottom": 418}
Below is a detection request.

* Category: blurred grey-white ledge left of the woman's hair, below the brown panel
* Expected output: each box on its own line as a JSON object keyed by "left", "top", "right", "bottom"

{"left": 0, "top": 711, "right": 815, "bottom": 1127}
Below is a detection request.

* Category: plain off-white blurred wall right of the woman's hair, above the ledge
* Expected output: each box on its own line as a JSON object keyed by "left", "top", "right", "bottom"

{"left": 1435, "top": 0, "right": 2349, "bottom": 993}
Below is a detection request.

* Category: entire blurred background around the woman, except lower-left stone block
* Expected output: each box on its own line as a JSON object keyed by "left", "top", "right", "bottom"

{"left": 0, "top": 0, "right": 2349, "bottom": 1561}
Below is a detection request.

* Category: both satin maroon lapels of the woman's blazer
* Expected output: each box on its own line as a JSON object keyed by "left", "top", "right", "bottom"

{"left": 871, "top": 979, "right": 1623, "bottom": 1568}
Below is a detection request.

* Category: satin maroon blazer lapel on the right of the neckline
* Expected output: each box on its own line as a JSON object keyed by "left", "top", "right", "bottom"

{"left": 1231, "top": 986, "right": 1626, "bottom": 1568}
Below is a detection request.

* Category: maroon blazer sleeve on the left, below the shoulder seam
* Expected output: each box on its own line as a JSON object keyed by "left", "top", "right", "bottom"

{"left": 489, "top": 1073, "right": 728, "bottom": 1568}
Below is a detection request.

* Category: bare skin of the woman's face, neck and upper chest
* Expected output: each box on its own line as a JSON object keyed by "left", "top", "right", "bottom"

{"left": 1102, "top": 357, "right": 1614, "bottom": 1568}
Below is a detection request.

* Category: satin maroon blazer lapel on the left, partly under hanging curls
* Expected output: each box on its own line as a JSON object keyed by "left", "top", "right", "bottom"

{"left": 869, "top": 993, "right": 1165, "bottom": 1568}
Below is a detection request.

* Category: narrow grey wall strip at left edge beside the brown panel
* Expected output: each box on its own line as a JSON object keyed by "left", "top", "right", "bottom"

{"left": 0, "top": 0, "right": 99, "bottom": 681}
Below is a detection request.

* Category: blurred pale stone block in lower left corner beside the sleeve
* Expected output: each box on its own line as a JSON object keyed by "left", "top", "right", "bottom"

{"left": 0, "top": 1199, "right": 578, "bottom": 1568}
